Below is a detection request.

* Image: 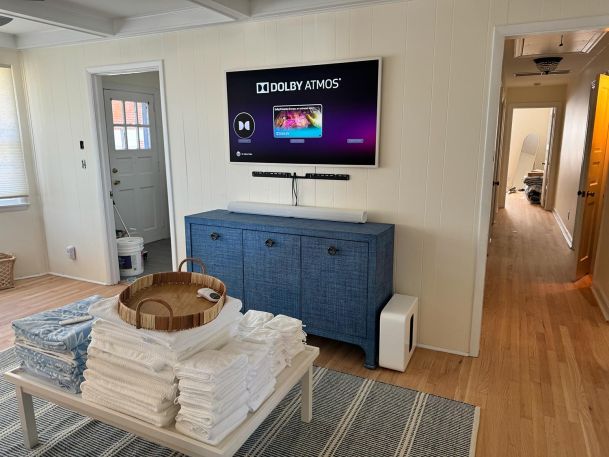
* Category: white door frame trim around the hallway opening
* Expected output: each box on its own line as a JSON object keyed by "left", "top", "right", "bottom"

{"left": 469, "top": 16, "right": 609, "bottom": 357}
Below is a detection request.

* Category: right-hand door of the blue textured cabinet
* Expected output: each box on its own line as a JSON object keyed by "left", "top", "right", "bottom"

{"left": 301, "top": 237, "right": 368, "bottom": 337}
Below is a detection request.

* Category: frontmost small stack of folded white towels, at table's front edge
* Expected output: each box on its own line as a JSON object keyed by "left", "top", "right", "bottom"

{"left": 175, "top": 350, "right": 249, "bottom": 445}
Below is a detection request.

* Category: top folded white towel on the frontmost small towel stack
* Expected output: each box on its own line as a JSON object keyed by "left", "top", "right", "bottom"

{"left": 175, "top": 350, "right": 247, "bottom": 381}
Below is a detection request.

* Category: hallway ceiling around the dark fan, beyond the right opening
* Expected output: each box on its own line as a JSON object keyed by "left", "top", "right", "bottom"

{"left": 503, "top": 30, "right": 609, "bottom": 87}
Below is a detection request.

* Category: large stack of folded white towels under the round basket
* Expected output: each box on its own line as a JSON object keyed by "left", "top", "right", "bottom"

{"left": 81, "top": 297, "right": 242, "bottom": 427}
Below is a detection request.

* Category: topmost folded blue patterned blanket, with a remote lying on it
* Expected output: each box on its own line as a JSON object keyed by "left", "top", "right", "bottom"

{"left": 13, "top": 295, "right": 103, "bottom": 357}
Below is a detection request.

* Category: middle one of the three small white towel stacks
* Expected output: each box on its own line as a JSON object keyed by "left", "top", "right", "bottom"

{"left": 221, "top": 340, "right": 276, "bottom": 412}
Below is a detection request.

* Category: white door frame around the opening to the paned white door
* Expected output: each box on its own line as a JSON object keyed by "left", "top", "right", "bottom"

{"left": 86, "top": 60, "right": 177, "bottom": 284}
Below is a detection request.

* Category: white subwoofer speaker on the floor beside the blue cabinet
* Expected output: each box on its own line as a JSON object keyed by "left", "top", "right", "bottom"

{"left": 379, "top": 294, "right": 419, "bottom": 371}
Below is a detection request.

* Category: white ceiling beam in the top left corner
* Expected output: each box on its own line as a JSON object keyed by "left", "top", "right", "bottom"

{"left": 0, "top": 0, "right": 114, "bottom": 37}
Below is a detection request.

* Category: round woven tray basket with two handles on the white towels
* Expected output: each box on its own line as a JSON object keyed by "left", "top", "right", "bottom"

{"left": 118, "top": 258, "right": 226, "bottom": 332}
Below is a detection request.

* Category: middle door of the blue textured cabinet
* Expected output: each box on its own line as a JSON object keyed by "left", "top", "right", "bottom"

{"left": 243, "top": 230, "right": 300, "bottom": 318}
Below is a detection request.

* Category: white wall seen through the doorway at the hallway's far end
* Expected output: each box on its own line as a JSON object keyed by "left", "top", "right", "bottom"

{"left": 507, "top": 108, "right": 552, "bottom": 189}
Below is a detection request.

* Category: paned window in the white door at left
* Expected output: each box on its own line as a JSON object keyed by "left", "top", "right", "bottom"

{"left": 112, "top": 99, "right": 151, "bottom": 151}
